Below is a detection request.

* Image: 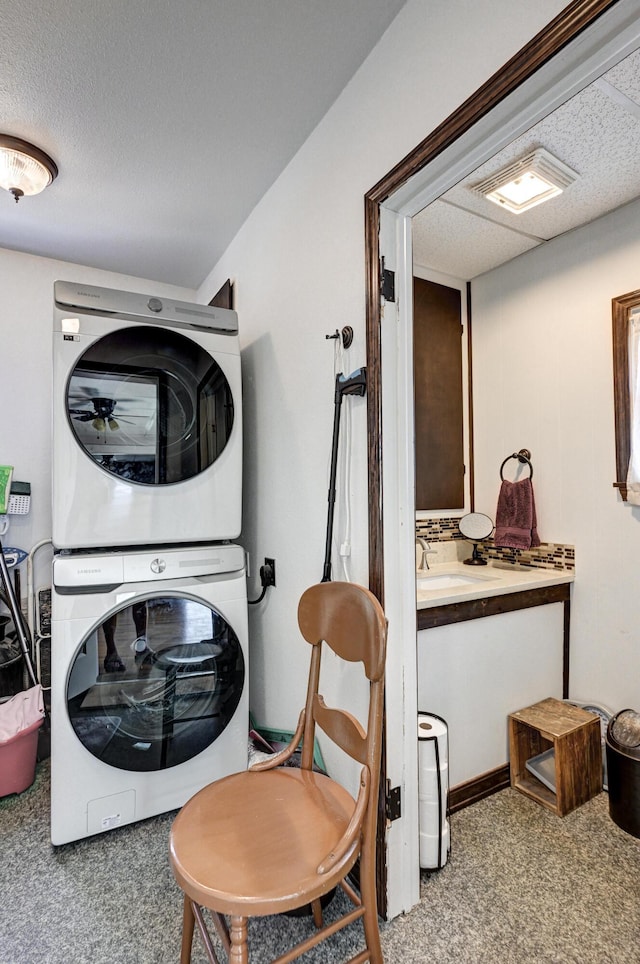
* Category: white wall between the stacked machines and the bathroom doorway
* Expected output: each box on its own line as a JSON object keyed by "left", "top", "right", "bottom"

{"left": 198, "top": 0, "right": 563, "bottom": 744}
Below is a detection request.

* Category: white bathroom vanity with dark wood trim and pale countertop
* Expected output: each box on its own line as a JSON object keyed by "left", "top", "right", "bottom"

{"left": 416, "top": 561, "right": 573, "bottom": 810}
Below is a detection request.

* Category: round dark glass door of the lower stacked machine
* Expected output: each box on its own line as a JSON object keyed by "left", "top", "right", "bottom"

{"left": 67, "top": 595, "right": 245, "bottom": 771}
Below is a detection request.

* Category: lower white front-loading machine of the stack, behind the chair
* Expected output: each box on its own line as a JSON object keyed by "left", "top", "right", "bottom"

{"left": 51, "top": 544, "right": 249, "bottom": 844}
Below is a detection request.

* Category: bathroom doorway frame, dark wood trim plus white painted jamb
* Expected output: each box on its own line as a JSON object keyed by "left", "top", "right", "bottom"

{"left": 365, "top": 0, "right": 624, "bottom": 919}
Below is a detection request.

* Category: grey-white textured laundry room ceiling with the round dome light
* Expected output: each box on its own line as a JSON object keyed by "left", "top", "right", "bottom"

{"left": 0, "top": 0, "right": 405, "bottom": 287}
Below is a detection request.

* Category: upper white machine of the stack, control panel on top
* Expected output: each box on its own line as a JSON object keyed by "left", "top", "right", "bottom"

{"left": 52, "top": 281, "right": 242, "bottom": 549}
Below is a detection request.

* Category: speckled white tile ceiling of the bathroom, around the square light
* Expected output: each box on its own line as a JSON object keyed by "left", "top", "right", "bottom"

{"left": 413, "top": 51, "right": 640, "bottom": 280}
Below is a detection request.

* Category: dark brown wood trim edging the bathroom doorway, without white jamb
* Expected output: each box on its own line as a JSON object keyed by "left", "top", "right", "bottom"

{"left": 364, "top": 0, "right": 617, "bottom": 916}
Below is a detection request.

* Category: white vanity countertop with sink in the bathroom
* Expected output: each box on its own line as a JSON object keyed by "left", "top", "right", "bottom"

{"left": 416, "top": 562, "right": 574, "bottom": 609}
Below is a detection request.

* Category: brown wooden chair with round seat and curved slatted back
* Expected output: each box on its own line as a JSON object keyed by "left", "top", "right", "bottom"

{"left": 170, "top": 582, "right": 386, "bottom": 964}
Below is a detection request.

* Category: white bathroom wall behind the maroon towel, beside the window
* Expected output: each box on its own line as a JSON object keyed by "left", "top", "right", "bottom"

{"left": 472, "top": 196, "right": 640, "bottom": 710}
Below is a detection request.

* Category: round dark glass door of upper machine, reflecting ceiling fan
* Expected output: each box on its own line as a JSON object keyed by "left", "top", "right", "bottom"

{"left": 66, "top": 325, "right": 233, "bottom": 485}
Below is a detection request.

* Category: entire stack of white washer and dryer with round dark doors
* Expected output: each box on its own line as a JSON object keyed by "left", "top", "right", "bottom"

{"left": 51, "top": 282, "right": 249, "bottom": 844}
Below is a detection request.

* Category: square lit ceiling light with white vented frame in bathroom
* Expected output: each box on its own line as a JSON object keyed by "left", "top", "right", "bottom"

{"left": 473, "top": 147, "right": 578, "bottom": 214}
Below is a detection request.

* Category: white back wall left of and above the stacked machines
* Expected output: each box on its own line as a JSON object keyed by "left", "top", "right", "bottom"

{"left": 0, "top": 248, "right": 195, "bottom": 591}
